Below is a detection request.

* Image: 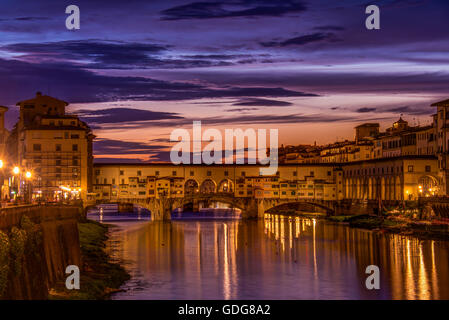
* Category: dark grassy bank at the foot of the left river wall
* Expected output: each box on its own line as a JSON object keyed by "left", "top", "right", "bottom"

{"left": 49, "top": 220, "right": 130, "bottom": 300}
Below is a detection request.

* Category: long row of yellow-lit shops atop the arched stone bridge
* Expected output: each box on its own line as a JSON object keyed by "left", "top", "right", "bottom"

{"left": 94, "top": 163, "right": 344, "bottom": 202}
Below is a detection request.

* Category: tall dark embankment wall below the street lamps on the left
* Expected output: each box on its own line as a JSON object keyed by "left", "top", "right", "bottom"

{"left": 0, "top": 206, "right": 82, "bottom": 300}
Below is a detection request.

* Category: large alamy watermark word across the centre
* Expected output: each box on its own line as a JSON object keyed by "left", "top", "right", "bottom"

{"left": 170, "top": 121, "right": 278, "bottom": 175}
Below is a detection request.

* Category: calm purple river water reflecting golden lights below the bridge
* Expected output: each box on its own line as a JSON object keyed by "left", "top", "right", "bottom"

{"left": 87, "top": 214, "right": 449, "bottom": 299}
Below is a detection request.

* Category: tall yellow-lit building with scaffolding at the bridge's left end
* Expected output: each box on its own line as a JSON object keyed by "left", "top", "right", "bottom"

{"left": 16, "top": 92, "right": 94, "bottom": 200}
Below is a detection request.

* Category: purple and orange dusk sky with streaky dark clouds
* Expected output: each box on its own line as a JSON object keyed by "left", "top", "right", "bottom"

{"left": 0, "top": 0, "right": 449, "bottom": 161}
